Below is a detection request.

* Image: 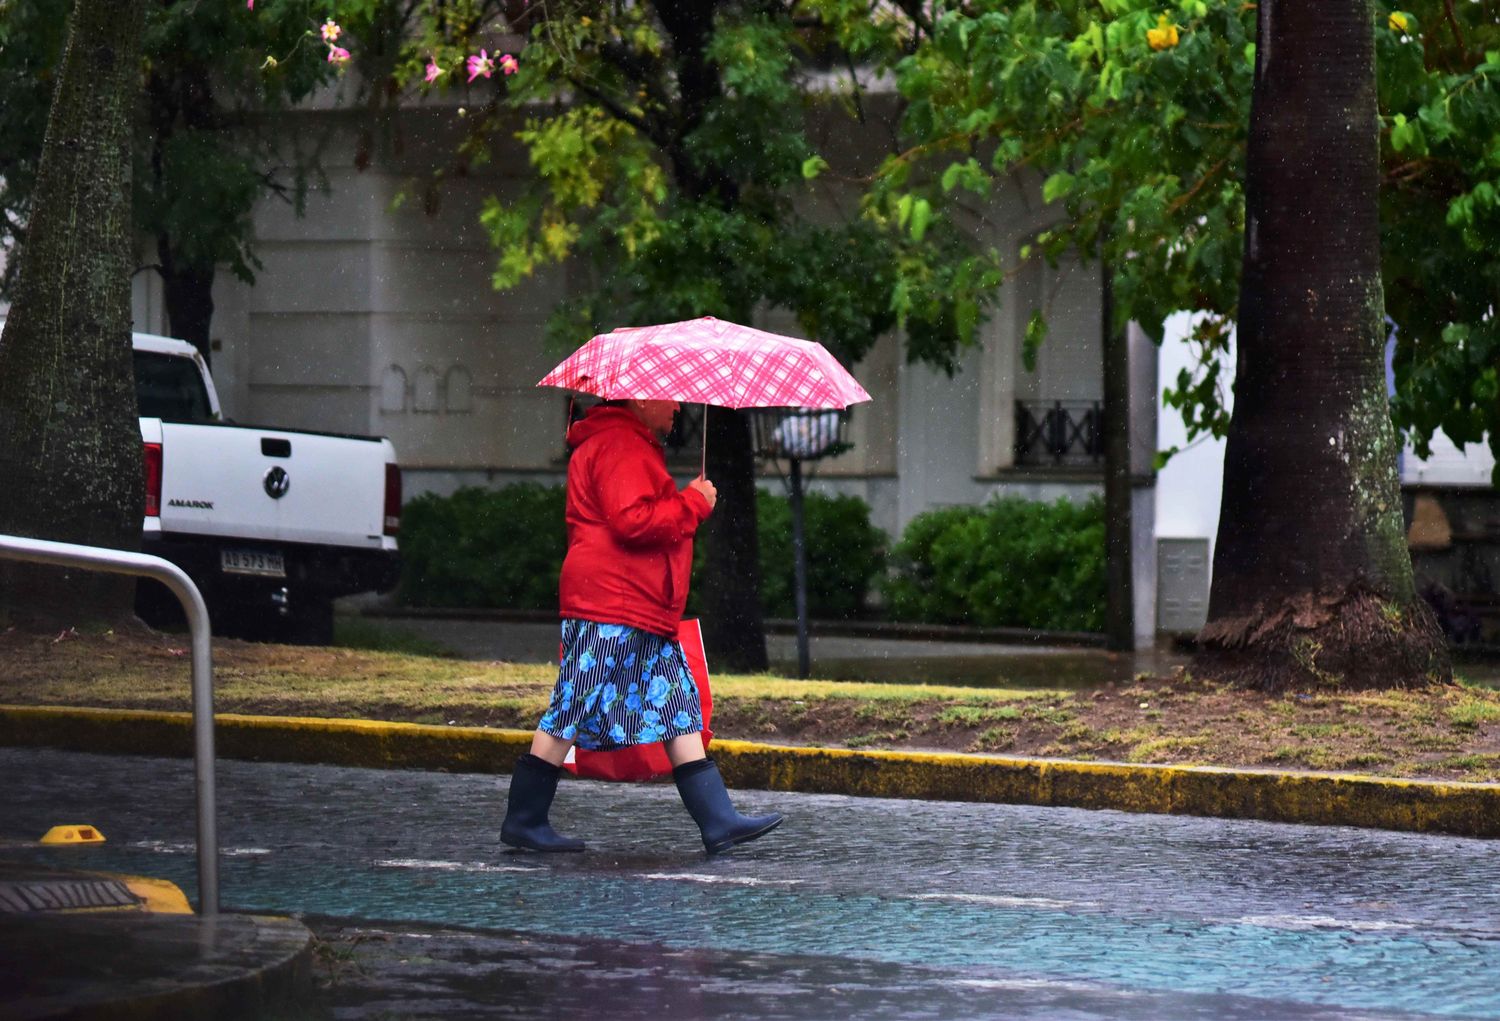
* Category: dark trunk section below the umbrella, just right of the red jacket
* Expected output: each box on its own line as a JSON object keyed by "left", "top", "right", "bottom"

{"left": 696, "top": 408, "right": 768, "bottom": 673}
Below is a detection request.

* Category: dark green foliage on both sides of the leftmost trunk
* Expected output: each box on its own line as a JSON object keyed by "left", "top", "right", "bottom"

{"left": 0, "top": 0, "right": 369, "bottom": 357}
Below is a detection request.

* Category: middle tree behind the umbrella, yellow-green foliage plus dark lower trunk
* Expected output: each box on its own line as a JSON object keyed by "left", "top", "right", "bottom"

{"left": 408, "top": 0, "right": 977, "bottom": 669}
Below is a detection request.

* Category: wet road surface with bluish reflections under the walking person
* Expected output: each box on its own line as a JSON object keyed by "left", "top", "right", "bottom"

{"left": 0, "top": 740, "right": 1500, "bottom": 1021}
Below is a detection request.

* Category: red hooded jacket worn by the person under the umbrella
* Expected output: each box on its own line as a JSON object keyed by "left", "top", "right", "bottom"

{"left": 558, "top": 406, "right": 711, "bottom": 637}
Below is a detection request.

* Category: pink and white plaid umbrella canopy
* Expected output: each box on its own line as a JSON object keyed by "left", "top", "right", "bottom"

{"left": 537, "top": 316, "right": 870, "bottom": 408}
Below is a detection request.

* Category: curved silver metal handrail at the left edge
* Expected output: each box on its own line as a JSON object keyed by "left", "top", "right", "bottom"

{"left": 0, "top": 535, "right": 219, "bottom": 915}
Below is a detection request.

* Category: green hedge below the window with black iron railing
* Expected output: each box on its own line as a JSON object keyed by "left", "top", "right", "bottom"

{"left": 884, "top": 496, "right": 1106, "bottom": 631}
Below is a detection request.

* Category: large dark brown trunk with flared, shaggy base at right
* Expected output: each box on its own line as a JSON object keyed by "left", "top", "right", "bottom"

{"left": 1196, "top": 0, "right": 1451, "bottom": 690}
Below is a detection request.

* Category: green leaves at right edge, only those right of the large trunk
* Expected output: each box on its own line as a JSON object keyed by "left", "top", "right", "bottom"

{"left": 1376, "top": 0, "right": 1500, "bottom": 481}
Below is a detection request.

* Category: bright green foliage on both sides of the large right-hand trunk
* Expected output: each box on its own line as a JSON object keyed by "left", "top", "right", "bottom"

{"left": 866, "top": 0, "right": 1500, "bottom": 470}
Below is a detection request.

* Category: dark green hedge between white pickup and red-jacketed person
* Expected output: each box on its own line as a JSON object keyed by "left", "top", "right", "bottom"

{"left": 399, "top": 483, "right": 567, "bottom": 610}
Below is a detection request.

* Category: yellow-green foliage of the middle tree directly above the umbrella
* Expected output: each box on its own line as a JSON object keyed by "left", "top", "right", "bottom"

{"left": 404, "top": 0, "right": 948, "bottom": 371}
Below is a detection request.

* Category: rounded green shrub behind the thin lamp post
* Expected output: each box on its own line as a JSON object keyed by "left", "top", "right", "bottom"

{"left": 756, "top": 489, "right": 885, "bottom": 621}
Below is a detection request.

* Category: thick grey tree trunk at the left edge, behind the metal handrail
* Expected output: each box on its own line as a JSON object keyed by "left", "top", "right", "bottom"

{"left": 0, "top": 0, "right": 146, "bottom": 627}
